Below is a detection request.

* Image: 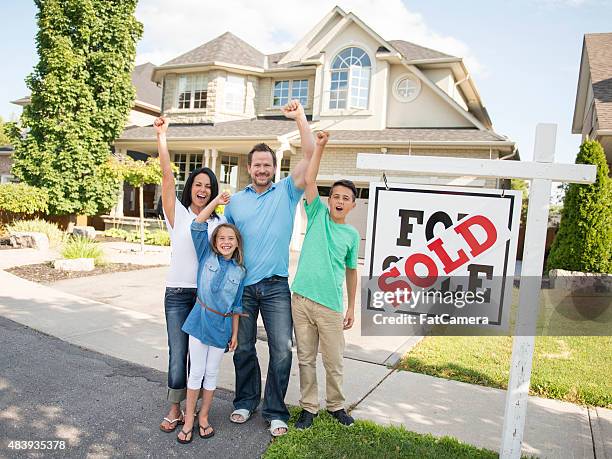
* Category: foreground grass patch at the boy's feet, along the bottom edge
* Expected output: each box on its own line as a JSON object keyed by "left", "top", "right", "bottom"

{"left": 263, "top": 408, "right": 498, "bottom": 459}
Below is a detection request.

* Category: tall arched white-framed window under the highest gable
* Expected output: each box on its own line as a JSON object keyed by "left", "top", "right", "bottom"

{"left": 327, "top": 44, "right": 373, "bottom": 111}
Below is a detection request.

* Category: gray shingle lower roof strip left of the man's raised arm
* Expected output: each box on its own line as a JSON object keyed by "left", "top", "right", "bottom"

{"left": 118, "top": 120, "right": 296, "bottom": 140}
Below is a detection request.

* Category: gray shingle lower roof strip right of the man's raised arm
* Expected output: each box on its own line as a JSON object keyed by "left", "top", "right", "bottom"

{"left": 329, "top": 128, "right": 501, "bottom": 143}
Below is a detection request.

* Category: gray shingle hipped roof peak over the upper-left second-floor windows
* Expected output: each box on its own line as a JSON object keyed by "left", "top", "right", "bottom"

{"left": 162, "top": 32, "right": 264, "bottom": 68}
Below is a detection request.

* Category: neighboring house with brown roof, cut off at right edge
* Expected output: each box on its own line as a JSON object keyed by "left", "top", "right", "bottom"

{"left": 572, "top": 32, "right": 612, "bottom": 170}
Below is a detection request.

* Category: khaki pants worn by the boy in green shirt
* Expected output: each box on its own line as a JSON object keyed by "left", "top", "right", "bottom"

{"left": 291, "top": 293, "right": 344, "bottom": 414}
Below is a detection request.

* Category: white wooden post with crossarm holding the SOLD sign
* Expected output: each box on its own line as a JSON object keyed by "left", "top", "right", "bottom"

{"left": 357, "top": 124, "right": 596, "bottom": 459}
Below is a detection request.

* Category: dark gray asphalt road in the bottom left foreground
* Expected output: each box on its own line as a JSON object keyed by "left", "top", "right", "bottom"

{"left": 0, "top": 317, "right": 270, "bottom": 458}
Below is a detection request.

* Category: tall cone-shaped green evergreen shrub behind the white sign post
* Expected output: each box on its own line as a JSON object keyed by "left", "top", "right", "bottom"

{"left": 546, "top": 140, "right": 612, "bottom": 273}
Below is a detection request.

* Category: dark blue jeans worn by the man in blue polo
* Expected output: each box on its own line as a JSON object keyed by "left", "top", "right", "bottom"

{"left": 234, "top": 276, "right": 293, "bottom": 422}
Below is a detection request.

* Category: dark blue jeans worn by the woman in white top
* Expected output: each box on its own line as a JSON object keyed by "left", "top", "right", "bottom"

{"left": 164, "top": 287, "right": 197, "bottom": 403}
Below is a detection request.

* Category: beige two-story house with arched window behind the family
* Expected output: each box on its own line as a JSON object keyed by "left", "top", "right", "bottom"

{"left": 115, "top": 7, "right": 518, "bottom": 253}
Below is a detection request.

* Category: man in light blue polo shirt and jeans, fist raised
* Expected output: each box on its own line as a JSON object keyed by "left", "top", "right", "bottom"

{"left": 225, "top": 101, "right": 314, "bottom": 437}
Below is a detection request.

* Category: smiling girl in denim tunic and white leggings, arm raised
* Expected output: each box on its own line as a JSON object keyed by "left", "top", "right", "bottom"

{"left": 177, "top": 193, "right": 246, "bottom": 443}
